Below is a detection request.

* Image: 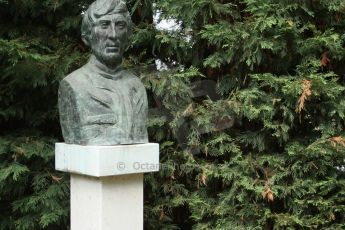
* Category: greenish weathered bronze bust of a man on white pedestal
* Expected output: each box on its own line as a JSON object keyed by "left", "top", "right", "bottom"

{"left": 59, "top": 0, "right": 148, "bottom": 145}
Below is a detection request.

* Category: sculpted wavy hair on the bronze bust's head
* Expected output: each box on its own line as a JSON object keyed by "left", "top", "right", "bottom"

{"left": 81, "top": 0, "right": 132, "bottom": 46}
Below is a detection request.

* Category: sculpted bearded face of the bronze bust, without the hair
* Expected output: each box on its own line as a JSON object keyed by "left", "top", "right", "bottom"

{"left": 91, "top": 13, "right": 128, "bottom": 68}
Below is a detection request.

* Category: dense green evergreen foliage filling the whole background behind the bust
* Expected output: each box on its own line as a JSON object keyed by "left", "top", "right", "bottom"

{"left": 0, "top": 0, "right": 345, "bottom": 229}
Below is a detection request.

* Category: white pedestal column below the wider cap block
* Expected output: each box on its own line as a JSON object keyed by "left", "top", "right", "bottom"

{"left": 71, "top": 174, "right": 144, "bottom": 230}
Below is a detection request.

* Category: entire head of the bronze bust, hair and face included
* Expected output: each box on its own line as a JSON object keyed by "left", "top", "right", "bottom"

{"left": 81, "top": 0, "right": 132, "bottom": 68}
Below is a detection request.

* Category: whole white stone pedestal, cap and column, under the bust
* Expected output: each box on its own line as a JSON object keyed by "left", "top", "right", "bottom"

{"left": 55, "top": 143, "right": 159, "bottom": 230}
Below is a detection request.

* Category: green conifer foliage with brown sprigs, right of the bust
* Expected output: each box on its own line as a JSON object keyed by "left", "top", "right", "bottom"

{"left": 141, "top": 0, "right": 345, "bottom": 229}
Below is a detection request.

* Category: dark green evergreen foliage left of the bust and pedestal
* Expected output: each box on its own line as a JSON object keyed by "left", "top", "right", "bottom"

{"left": 0, "top": 0, "right": 91, "bottom": 230}
